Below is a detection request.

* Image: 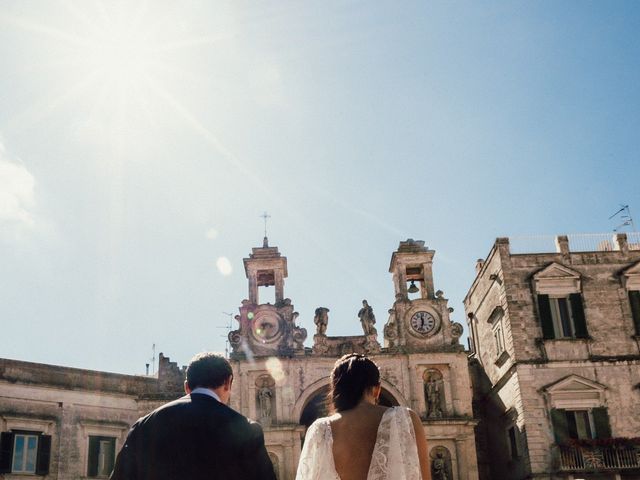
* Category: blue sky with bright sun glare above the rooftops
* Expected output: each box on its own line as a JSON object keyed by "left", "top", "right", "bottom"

{"left": 0, "top": 0, "right": 640, "bottom": 373}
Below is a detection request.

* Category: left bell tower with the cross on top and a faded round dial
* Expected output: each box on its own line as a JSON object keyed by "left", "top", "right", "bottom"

{"left": 229, "top": 236, "right": 307, "bottom": 359}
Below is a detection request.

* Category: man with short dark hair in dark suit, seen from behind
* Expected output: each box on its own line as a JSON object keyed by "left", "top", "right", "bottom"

{"left": 110, "top": 353, "right": 276, "bottom": 480}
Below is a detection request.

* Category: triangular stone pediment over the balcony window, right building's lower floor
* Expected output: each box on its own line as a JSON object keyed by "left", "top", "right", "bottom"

{"left": 543, "top": 375, "right": 607, "bottom": 409}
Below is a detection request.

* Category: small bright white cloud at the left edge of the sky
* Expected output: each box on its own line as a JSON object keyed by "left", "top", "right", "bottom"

{"left": 0, "top": 143, "right": 36, "bottom": 229}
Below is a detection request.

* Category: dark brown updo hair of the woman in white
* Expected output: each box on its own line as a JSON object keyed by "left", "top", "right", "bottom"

{"left": 328, "top": 353, "right": 380, "bottom": 412}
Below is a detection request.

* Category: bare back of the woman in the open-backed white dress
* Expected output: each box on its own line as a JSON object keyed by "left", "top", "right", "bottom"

{"left": 330, "top": 403, "right": 387, "bottom": 480}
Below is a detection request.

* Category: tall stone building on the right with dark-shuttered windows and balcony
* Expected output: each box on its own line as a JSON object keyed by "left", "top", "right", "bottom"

{"left": 464, "top": 233, "right": 640, "bottom": 479}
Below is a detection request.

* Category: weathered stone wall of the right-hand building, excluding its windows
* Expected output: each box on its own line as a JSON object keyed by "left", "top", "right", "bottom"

{"left": 465, "top": 239, "right": 640, "bottom": 479}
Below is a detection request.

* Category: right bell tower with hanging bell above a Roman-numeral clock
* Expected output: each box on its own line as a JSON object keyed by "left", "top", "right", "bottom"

{"left": 384, "top": 238, "right": 463, "bottom": 353}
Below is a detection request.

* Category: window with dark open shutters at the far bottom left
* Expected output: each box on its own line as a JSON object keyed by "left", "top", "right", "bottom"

{"left": 0, "top": 431, "right": 51, "bottom": 475}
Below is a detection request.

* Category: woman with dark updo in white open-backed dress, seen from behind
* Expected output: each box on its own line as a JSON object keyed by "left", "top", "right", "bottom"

{"left": 296, "top": 353, "right": 431, "bottom": 480}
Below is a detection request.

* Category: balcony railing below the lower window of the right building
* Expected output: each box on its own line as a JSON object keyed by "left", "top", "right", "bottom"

{"left": 558, "top": 445, "right": 640, "bottom": 472}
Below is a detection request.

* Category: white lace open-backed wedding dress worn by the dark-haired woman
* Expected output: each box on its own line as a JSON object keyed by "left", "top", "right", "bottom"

{"left": 296, "top": 407, "right": 421, "bottom": 480}
